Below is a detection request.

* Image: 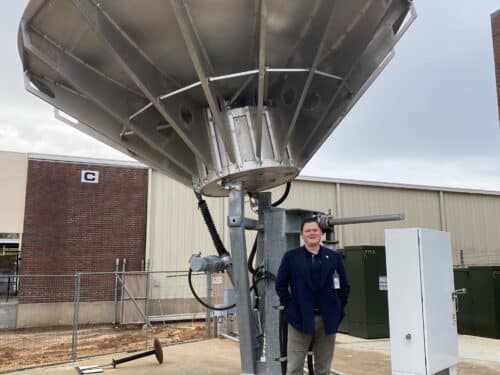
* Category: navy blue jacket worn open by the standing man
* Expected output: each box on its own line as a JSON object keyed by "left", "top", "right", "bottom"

{"left": 276, "top": 246, "right": 349, "bottom": 335}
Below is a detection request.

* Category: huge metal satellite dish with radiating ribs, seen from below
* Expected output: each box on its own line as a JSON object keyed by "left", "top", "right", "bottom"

{"left": 19, "top": 0, "right": 415, "bottom": 196}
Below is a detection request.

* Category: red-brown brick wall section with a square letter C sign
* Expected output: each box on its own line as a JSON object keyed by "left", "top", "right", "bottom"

{"left": 18, "top": 157, "right": 148, "bottom": 303}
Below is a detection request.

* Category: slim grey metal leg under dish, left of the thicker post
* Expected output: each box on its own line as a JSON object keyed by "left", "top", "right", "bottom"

{"left": 228, "top": 182, "right": 257, "bottom": 374}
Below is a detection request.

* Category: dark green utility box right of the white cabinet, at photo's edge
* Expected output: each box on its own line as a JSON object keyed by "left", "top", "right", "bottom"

{"left": 454, "top": 266, "right": 500, "bottom": 339}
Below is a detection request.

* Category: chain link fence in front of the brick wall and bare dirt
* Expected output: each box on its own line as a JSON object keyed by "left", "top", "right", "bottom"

{"left": 0, "top": 271, "right": 215, "bottom": 372}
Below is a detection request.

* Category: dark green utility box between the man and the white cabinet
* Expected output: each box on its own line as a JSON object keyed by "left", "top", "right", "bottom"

{"left": 340, "top": 246, "right": 389, "bottom": 339}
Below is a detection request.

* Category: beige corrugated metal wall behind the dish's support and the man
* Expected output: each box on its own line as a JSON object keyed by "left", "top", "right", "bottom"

{"left": 148, "top": 172, "right": 500, "bottom": 269}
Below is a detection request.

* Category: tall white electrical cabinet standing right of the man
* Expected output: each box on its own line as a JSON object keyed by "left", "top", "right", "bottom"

{"left": 385, "top": 228, "right": 458, "bottom": 375}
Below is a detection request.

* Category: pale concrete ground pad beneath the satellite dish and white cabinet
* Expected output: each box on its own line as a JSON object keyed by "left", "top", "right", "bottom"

{"left": 13, "top": 334, "right": 500, "bottom": 375}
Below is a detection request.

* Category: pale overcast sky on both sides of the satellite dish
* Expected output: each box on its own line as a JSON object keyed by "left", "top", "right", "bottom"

{"left": 0, "top": 0, "right": 500, "bottom": 190}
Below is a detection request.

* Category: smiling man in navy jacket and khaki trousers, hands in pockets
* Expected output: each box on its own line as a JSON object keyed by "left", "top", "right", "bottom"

{"left": 276, "top": 219, "right": 349, "bottom": 375}
